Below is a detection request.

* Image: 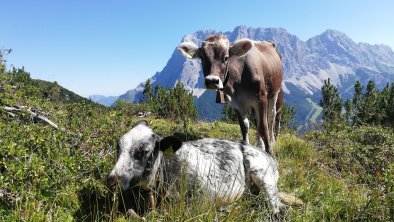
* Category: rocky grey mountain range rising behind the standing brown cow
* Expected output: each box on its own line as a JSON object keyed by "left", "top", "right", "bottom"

{"left": 119, "top": 26, "right": 394, "bottom": 124}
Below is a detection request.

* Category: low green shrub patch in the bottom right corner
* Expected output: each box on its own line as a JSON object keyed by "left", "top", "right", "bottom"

{"left": 306, "top": 126, "right": 394, "bottom": 221}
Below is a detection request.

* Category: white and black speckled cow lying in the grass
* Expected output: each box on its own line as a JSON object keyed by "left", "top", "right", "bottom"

{"left": 107, "top": 122, "right": 296, "bottom": 219}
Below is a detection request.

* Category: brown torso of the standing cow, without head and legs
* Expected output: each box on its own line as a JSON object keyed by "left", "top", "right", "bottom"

{"left": 225, "top": 41, "right": 283, "bottom": 104}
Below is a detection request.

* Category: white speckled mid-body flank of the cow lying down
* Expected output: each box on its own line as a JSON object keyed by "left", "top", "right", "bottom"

{"left": 177, "top": 139, "right": 246, "bottom": 202}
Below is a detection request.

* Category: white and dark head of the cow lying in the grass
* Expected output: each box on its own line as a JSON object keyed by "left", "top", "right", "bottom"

{"left": 106, "top": 121, "right": 182, "bottom": 191}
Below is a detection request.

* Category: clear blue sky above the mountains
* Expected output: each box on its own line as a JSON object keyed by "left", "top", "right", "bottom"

{"left": 0, "top": 0, "right": 394, "bottom": 96}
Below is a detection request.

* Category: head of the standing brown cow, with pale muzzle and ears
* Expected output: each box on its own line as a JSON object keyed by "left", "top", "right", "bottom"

{"left": 178, "top": 35, "right": 253, "bottom": 89}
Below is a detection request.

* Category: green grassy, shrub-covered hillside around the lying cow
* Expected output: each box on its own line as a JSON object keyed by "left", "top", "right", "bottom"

{"left": 0, "top": 61, "right": 394, "bottom": 221}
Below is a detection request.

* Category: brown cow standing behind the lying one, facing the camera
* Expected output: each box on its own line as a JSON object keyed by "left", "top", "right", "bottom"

{"left": 179, "top": 35, "right": 283, "bottom": 155}
